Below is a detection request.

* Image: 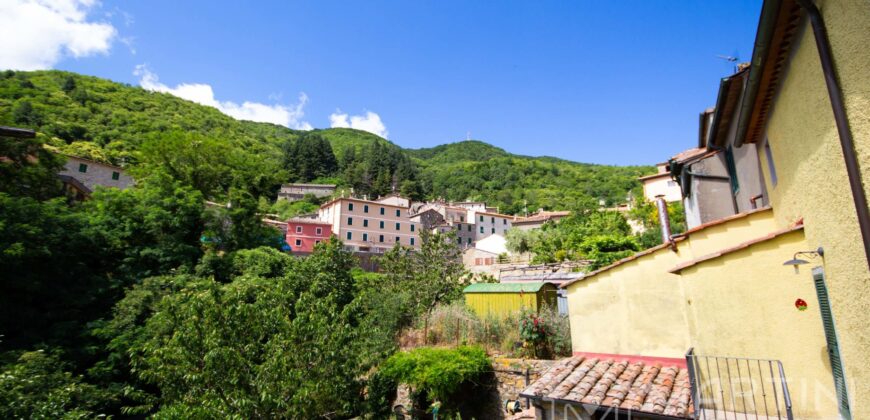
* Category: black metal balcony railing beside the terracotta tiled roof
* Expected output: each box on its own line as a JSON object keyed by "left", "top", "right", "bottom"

{"left": 686, "top": 349, "right": 794, "bottom": 420}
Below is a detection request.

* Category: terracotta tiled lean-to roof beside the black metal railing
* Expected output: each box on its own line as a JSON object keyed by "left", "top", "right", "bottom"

{"left": 520, "top": 355, "right": 694, "bottom": 418}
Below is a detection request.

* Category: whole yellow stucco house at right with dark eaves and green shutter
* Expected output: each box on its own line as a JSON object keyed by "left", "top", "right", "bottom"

{"left": 548, "top": 0, "right": 870, "bottom": 418}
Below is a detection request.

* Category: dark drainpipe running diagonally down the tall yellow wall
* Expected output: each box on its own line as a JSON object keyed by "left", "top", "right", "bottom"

{"left": 797, "top": 0, "right": 870, "bottom": 267}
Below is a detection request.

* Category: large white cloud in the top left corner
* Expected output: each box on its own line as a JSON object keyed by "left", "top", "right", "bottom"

{"left": 0, "top": 0, "right": 117, "bottom": 70}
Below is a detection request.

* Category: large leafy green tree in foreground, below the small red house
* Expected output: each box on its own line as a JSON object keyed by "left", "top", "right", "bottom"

{"left": 133, "top": 240, "right": 368, "bottom": 418}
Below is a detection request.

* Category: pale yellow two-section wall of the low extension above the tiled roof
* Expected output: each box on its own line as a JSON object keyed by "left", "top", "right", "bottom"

{"left": 568, "top": 210, "right": 837, "bottom": 418}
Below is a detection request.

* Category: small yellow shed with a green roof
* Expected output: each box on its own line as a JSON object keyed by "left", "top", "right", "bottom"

{"left": 462, "top": 282, "right": 557, "bottom": 318}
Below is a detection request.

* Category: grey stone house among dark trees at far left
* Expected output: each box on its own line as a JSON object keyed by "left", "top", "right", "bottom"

{"left": 58, "top": 155, "right": 133, "bottom": 197}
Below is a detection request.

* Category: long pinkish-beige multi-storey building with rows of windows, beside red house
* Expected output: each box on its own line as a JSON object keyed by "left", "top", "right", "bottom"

{"left": 320, "top": 198, "right": 420, "bottom": 253}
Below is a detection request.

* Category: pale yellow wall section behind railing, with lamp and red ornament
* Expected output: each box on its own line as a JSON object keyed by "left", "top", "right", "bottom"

{"left": 681, "top": 231, "right": 837, "bottom": 418}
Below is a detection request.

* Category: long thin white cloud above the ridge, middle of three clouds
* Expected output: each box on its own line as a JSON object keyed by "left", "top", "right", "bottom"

{"left": 133, "top": 64, "right": 314, "bottom": 130}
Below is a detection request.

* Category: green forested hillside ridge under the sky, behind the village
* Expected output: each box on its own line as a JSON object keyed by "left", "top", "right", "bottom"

{"left": 0, "top": 71, "right": 652, "bottom": 213}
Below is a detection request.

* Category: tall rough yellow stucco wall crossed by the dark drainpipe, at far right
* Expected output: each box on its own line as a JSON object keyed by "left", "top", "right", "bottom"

{"left": 759, "top": 0, "right": 870, "bottom": 419}
